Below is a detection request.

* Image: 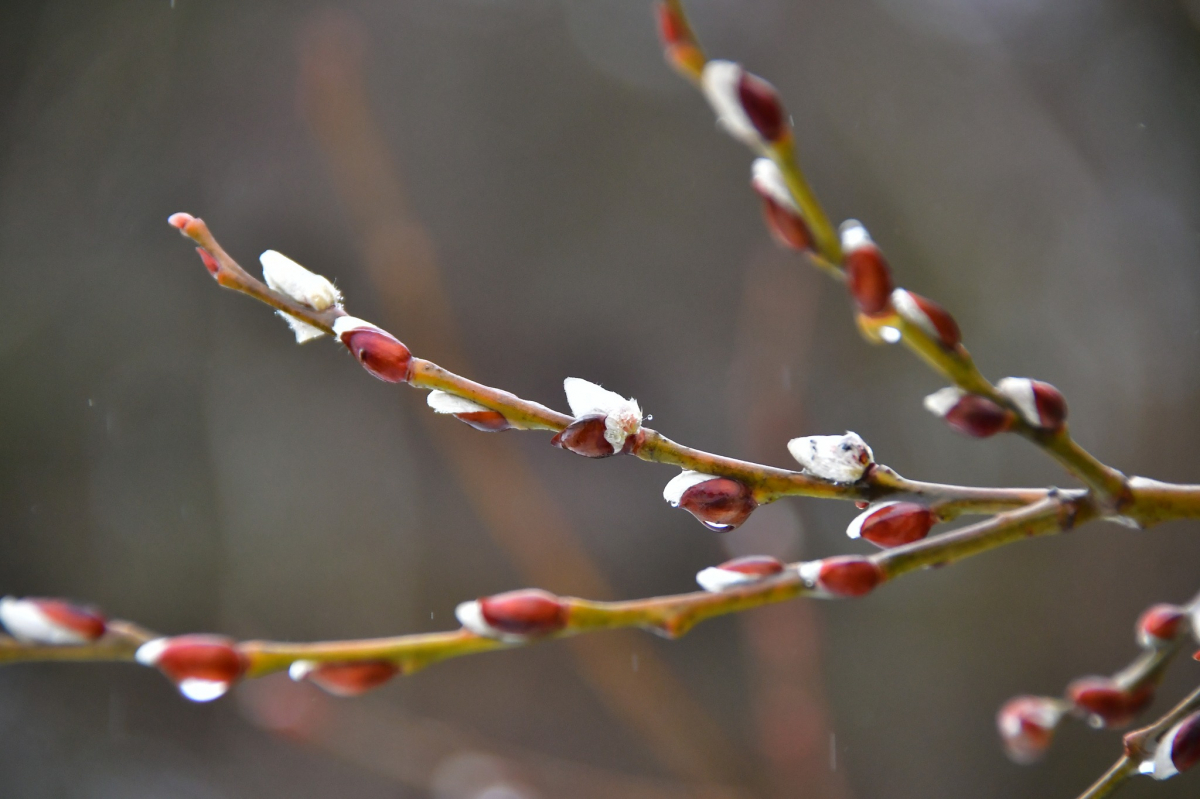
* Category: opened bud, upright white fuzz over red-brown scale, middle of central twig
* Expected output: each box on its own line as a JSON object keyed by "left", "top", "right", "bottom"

{"left": 550, "top": 378, "right": 642, "bottom": 458}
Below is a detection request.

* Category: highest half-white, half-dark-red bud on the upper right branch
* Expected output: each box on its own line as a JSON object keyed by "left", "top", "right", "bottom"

{"left": 701, "top": 60, "right": 791, "bottom": 149}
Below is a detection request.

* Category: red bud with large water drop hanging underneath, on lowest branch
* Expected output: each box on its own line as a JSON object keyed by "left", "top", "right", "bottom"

{"left": 134, "top": 635, "right": 248, "bottom": 702}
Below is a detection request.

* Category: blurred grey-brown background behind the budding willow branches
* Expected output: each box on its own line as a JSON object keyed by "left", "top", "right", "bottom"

{"left": 0, "top": 0, "right": 1200, "bottom": 799}
